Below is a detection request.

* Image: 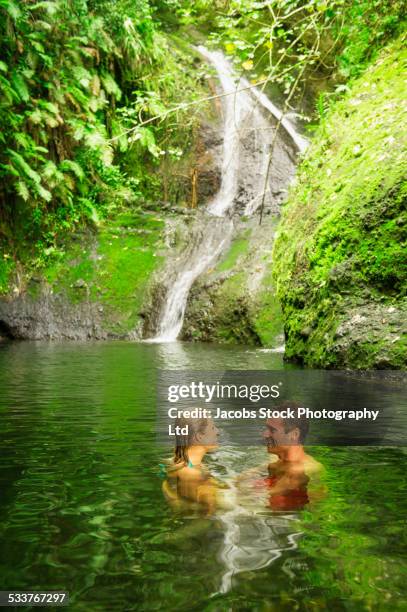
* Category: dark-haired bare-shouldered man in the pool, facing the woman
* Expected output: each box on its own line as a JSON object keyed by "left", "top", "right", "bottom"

{"left": 239, "top": 402, "right": 322, "bottom": 510}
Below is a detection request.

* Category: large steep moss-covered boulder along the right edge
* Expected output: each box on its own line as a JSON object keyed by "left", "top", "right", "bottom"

{"left": 273, "top": 41, "right": 407, "bottom": 368}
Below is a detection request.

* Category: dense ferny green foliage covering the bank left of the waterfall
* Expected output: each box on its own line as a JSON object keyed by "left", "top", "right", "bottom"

{"left": 0, "top": 0, "right": 204, "bottom": 290}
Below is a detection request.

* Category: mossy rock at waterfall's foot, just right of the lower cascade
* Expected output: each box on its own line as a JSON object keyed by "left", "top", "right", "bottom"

{"left": 182, "top": 215, "right": 282, "bottom": 346}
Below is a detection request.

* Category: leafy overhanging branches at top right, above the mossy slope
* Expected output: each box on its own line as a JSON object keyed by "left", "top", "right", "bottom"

{"left": 171, "top": 0, "right": 405, "bottom": 111}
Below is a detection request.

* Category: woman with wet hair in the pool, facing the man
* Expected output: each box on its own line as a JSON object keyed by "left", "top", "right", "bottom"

{"left": 163, "top": 418, "right": 226, "bottom": 514}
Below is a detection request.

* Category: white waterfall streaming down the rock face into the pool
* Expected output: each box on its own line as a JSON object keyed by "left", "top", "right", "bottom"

{"left": 148, "top": 46, "right": 306, "bottom": 342}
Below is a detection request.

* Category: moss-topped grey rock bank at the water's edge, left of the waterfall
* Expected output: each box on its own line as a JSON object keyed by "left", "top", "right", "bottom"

{"left": 0, "top": 210, "right": 165, "bottom": 339}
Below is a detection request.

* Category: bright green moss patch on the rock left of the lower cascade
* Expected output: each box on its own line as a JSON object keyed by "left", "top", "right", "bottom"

{"left": 34, "top": 209, "right": 164, "bottom": 337}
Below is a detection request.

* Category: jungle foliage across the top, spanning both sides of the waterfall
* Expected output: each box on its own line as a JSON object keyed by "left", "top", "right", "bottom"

{"left": 0, "top": 0, "right": 403, "bottom": 291}
